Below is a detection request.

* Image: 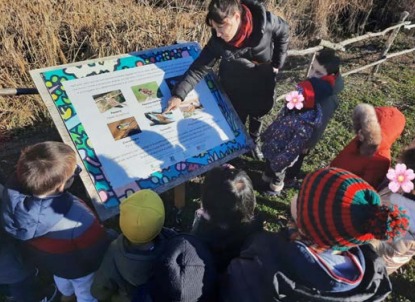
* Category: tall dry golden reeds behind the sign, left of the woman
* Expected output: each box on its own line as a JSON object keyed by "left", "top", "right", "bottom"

{"left": 0, "top": 0, "right": 209, "bottom": 129}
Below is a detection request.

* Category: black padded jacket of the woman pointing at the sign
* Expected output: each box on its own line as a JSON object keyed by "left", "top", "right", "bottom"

{"left": 172, "top": 0, "right": 289, "bottom": 116}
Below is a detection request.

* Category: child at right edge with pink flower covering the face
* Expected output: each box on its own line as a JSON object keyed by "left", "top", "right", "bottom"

{"left": 372, "top": 140, "right": 415, "bottom": 274}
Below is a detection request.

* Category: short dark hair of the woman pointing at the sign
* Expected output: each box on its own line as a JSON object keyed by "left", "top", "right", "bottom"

{"left": 205, "top": 0, "right": 242, "bottom": 26}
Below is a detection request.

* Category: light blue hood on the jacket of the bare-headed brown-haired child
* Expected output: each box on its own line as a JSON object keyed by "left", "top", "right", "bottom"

{"left": 1, "top": 179, "right": 73, "bottom": 240}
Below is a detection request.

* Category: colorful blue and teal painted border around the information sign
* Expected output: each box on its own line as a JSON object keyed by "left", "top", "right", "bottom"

{"left": 34, "top": 42, "right": 252, "bottom": 219}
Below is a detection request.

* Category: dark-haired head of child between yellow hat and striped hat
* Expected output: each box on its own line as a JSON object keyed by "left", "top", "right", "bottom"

{"left": 202, "top": 167, "right": 256, "bottom": 225}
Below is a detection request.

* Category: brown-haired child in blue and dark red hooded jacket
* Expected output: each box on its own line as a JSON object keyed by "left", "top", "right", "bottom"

{"left": 1, "top": 141, "right": 110, "bottom": 302}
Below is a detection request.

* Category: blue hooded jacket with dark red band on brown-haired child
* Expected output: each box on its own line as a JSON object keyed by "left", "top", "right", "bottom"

{"left": 1, "top": 181, "right": 110, "bottom": 279}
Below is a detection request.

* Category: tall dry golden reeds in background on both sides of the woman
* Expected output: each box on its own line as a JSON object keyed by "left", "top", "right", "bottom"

{"left": 0, "top": 0, "right": 412, "bottom": 130}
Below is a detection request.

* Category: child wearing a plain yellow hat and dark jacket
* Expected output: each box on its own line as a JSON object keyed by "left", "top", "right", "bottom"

{"left": 91, "top": 190, "right": 176, "bottom": 301}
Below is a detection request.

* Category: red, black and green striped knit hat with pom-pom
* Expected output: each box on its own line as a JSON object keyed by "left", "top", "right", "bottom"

{"left": 297, "top": 168, "right": 409, "bottom": 250}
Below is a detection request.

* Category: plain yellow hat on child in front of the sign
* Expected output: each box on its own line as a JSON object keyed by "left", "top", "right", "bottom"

{"left": 120, "top": 190, "right": 165, "bottom": 244}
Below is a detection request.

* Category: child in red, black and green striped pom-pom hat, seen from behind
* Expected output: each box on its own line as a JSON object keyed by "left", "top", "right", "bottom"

{"left": 284, "top": 168, "right": 409, "bottom": 292}
